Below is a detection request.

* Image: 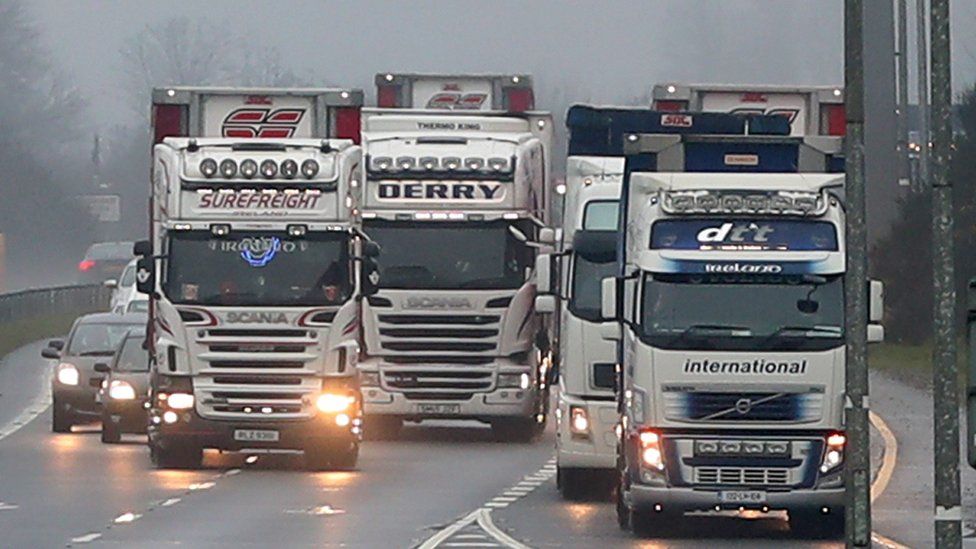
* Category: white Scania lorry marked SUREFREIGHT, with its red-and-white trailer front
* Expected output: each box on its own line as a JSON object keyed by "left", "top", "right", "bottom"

{"left": 135, "top": 88, "right": 377, "bottom": 469}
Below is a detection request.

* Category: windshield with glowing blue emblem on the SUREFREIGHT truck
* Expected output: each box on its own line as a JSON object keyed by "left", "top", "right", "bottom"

{"left": 163, "top": 231, "right": 352, "bottom": 306}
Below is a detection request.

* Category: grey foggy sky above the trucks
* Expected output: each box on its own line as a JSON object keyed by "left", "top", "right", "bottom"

{"left": 22, "top": 0, "right": 976, "bottom": 133}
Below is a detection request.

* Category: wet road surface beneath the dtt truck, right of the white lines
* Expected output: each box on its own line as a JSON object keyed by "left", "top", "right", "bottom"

{"left": 492, "top": 481, "right": 843, "bottom": 548}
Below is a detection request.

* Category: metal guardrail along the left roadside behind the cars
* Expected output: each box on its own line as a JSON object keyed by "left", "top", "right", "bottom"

{"left": 0, "top": 284, "right": 112, "bottom": 325}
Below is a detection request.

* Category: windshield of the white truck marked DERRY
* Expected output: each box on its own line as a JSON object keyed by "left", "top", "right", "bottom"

{"left": 364, "top": 221, "right": 533, "bottom": 290}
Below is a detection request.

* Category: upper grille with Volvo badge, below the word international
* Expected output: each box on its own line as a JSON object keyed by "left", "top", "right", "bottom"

{"left": 664, "top": 391, "right": 824, "bottom": 423}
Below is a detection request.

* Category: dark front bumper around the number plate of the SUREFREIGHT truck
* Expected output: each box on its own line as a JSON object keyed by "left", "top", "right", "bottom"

{"left": 148, "top": 410, "right": 362, "bottom": 452}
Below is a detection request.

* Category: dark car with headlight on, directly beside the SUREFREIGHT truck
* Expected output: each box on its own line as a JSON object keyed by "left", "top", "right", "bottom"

{"left": 95, "top": 328, "right": 149, "bottom": 442}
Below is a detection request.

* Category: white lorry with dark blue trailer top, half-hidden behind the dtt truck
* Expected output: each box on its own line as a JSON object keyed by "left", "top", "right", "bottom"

{"left": 536, "top": 105, "right": 788, "bottom": 498}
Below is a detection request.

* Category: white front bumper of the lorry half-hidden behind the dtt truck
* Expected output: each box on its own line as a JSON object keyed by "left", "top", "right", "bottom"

{"left": 556, "top": 394, "right": 618, "bottom": 469}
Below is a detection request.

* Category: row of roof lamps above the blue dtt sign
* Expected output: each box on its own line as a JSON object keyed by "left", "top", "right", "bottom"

{"left": 664, "top": 191, "right": 837, "bottom": 216}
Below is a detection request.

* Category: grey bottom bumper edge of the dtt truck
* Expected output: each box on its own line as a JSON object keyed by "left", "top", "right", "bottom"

{"left": 624, "top": 484, "right": 844, "bottom": 512}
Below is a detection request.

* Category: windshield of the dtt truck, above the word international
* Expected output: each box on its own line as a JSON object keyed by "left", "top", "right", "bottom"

{"left": 640, "top": 274, "right": 844, "bottom": 350}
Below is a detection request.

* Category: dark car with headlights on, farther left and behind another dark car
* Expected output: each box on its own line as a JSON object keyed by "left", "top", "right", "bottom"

{"left": 41, "top": 313, "right": 146, "bottom": 433}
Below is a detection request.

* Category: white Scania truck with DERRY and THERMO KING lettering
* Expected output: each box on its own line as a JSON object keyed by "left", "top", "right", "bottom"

{"left": 359, "top": 88, "right": 555, "bottom": 440}
